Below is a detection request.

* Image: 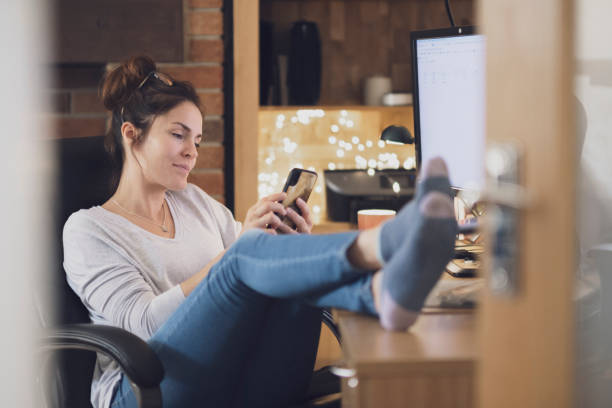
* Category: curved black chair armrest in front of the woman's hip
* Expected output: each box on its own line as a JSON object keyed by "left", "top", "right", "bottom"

{"left": 40, "top": 324, "right": 164, "bottom": 389}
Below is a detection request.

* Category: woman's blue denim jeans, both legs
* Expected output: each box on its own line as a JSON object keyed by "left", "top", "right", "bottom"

{"left": 112, "top": 231, "right": 376, "bottom": 408}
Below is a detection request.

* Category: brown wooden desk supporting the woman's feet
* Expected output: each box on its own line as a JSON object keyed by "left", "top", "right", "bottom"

{"left": 337, "top": 311, "right": 477, "bottom": 408}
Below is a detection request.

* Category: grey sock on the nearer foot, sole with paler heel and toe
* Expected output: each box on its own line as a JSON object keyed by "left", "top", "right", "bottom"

{"left": 379, "top": 191, "right": 457, "bottom": 330}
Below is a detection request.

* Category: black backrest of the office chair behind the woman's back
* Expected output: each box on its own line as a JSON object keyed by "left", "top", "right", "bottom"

{"left": 35, "top": 136, "right": 112, "bottom": 408}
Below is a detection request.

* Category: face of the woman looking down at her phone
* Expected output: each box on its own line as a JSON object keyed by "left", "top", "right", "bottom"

{"left": 133, "top": 101, "right": 202, "bottom": 190}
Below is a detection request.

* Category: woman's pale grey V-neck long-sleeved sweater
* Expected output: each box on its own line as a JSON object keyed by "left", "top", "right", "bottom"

{"left": 63, "top": 184, "right": 232, "bottom": 407}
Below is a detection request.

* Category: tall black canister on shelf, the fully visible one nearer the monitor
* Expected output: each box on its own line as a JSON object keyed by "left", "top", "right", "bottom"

{"left": 287, "top": 21, "right": 321, "bottom": 105}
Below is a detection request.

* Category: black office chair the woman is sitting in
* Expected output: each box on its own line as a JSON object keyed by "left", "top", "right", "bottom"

{"left": 35, "top": 137, "right": 340, "bottom": 408}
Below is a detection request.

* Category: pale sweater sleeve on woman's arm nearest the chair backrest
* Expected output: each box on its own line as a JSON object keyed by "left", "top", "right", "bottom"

{"left": 64, "top": 212, "right": 185, "bottom": 340}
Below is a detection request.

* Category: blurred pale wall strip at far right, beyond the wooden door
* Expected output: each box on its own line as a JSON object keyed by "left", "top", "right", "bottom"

{"left": 575, "top": 0, "right": 612, "bottom": 408}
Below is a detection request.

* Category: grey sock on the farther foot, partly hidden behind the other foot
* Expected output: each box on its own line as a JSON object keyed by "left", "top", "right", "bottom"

{"left": 378, "top": 158, "right": 453, "bottom": 265}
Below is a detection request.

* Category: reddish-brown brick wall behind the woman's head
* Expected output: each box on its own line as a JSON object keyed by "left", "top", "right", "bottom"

{"left": 49, "top": 0, "right": 225, "bottom": 202}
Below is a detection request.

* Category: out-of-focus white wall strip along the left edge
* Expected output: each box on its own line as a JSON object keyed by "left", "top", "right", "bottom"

{"left": 0, "top": 0, "right": 52, "bottom": 408}
